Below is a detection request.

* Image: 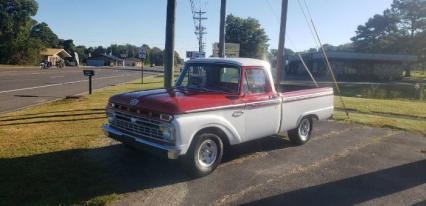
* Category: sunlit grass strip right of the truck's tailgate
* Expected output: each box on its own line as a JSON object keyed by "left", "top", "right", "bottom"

{"left": 334, "top": 97, "right": 426, "bottom": 135}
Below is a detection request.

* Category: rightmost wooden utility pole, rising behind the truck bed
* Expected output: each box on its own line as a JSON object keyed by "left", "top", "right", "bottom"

{"left": 275, "top": 0, "right": 288, "bottom": 90}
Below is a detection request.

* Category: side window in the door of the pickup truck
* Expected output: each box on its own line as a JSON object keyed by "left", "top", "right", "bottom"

{"left": 244, "top": 69, "right": 267, "bottom": 94}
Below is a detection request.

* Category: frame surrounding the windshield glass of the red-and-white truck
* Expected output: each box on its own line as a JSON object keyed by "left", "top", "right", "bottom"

{"left": 175, "top": 63, "right": 243, "bottom": 95}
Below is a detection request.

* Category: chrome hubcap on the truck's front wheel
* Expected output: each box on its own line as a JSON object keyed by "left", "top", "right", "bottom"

{"left": 197, "top": 139, "right": 217, "bottom": 167}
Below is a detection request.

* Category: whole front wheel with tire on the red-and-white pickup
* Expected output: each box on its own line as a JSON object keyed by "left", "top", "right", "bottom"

{"left": 184, "top": 133, "right": 223, "bottom": 177}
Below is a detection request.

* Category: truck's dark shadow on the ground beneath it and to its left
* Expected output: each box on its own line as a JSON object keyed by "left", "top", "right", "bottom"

{"left": 0, "top": 137, "right": 289, "bottom": 205}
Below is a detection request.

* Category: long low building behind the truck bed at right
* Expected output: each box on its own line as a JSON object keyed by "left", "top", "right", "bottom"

{"left": 284, "top": 52, "right": 417, "bottom": 80}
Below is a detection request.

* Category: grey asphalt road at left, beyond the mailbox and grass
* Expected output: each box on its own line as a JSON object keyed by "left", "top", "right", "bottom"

{"left": 0, "top": 67, "right": 152, "bottom": 113}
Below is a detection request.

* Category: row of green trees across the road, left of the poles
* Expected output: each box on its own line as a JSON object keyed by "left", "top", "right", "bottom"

{"left": 0, "top": 0, "right": 183, "bottom": 65}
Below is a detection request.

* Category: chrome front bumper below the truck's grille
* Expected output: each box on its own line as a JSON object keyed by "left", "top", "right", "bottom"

{"left": 102, "top": 124, "right": 180, "bottom": 159}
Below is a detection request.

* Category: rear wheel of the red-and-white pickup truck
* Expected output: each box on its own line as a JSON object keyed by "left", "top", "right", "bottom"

{"left": 288, "top": 117, "right": 313, "bottom": 145}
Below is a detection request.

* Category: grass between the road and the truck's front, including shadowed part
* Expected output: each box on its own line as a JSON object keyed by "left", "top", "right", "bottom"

{"left": 0, "top": 78, "right": 162, "bottom": 205}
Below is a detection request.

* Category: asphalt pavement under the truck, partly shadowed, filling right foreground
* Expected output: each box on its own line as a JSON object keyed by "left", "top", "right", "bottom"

{"left": 93, "top": 121, "right": 426, "bottom": 206}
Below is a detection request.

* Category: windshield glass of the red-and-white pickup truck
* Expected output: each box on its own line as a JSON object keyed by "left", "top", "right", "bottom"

{"left": 176, "top": 64, "right": 240, "bottom": 94}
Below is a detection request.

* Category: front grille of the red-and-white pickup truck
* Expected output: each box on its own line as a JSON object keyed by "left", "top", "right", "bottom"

{"left": 110, "top": 112, "right": 167, "bottom": 142}
